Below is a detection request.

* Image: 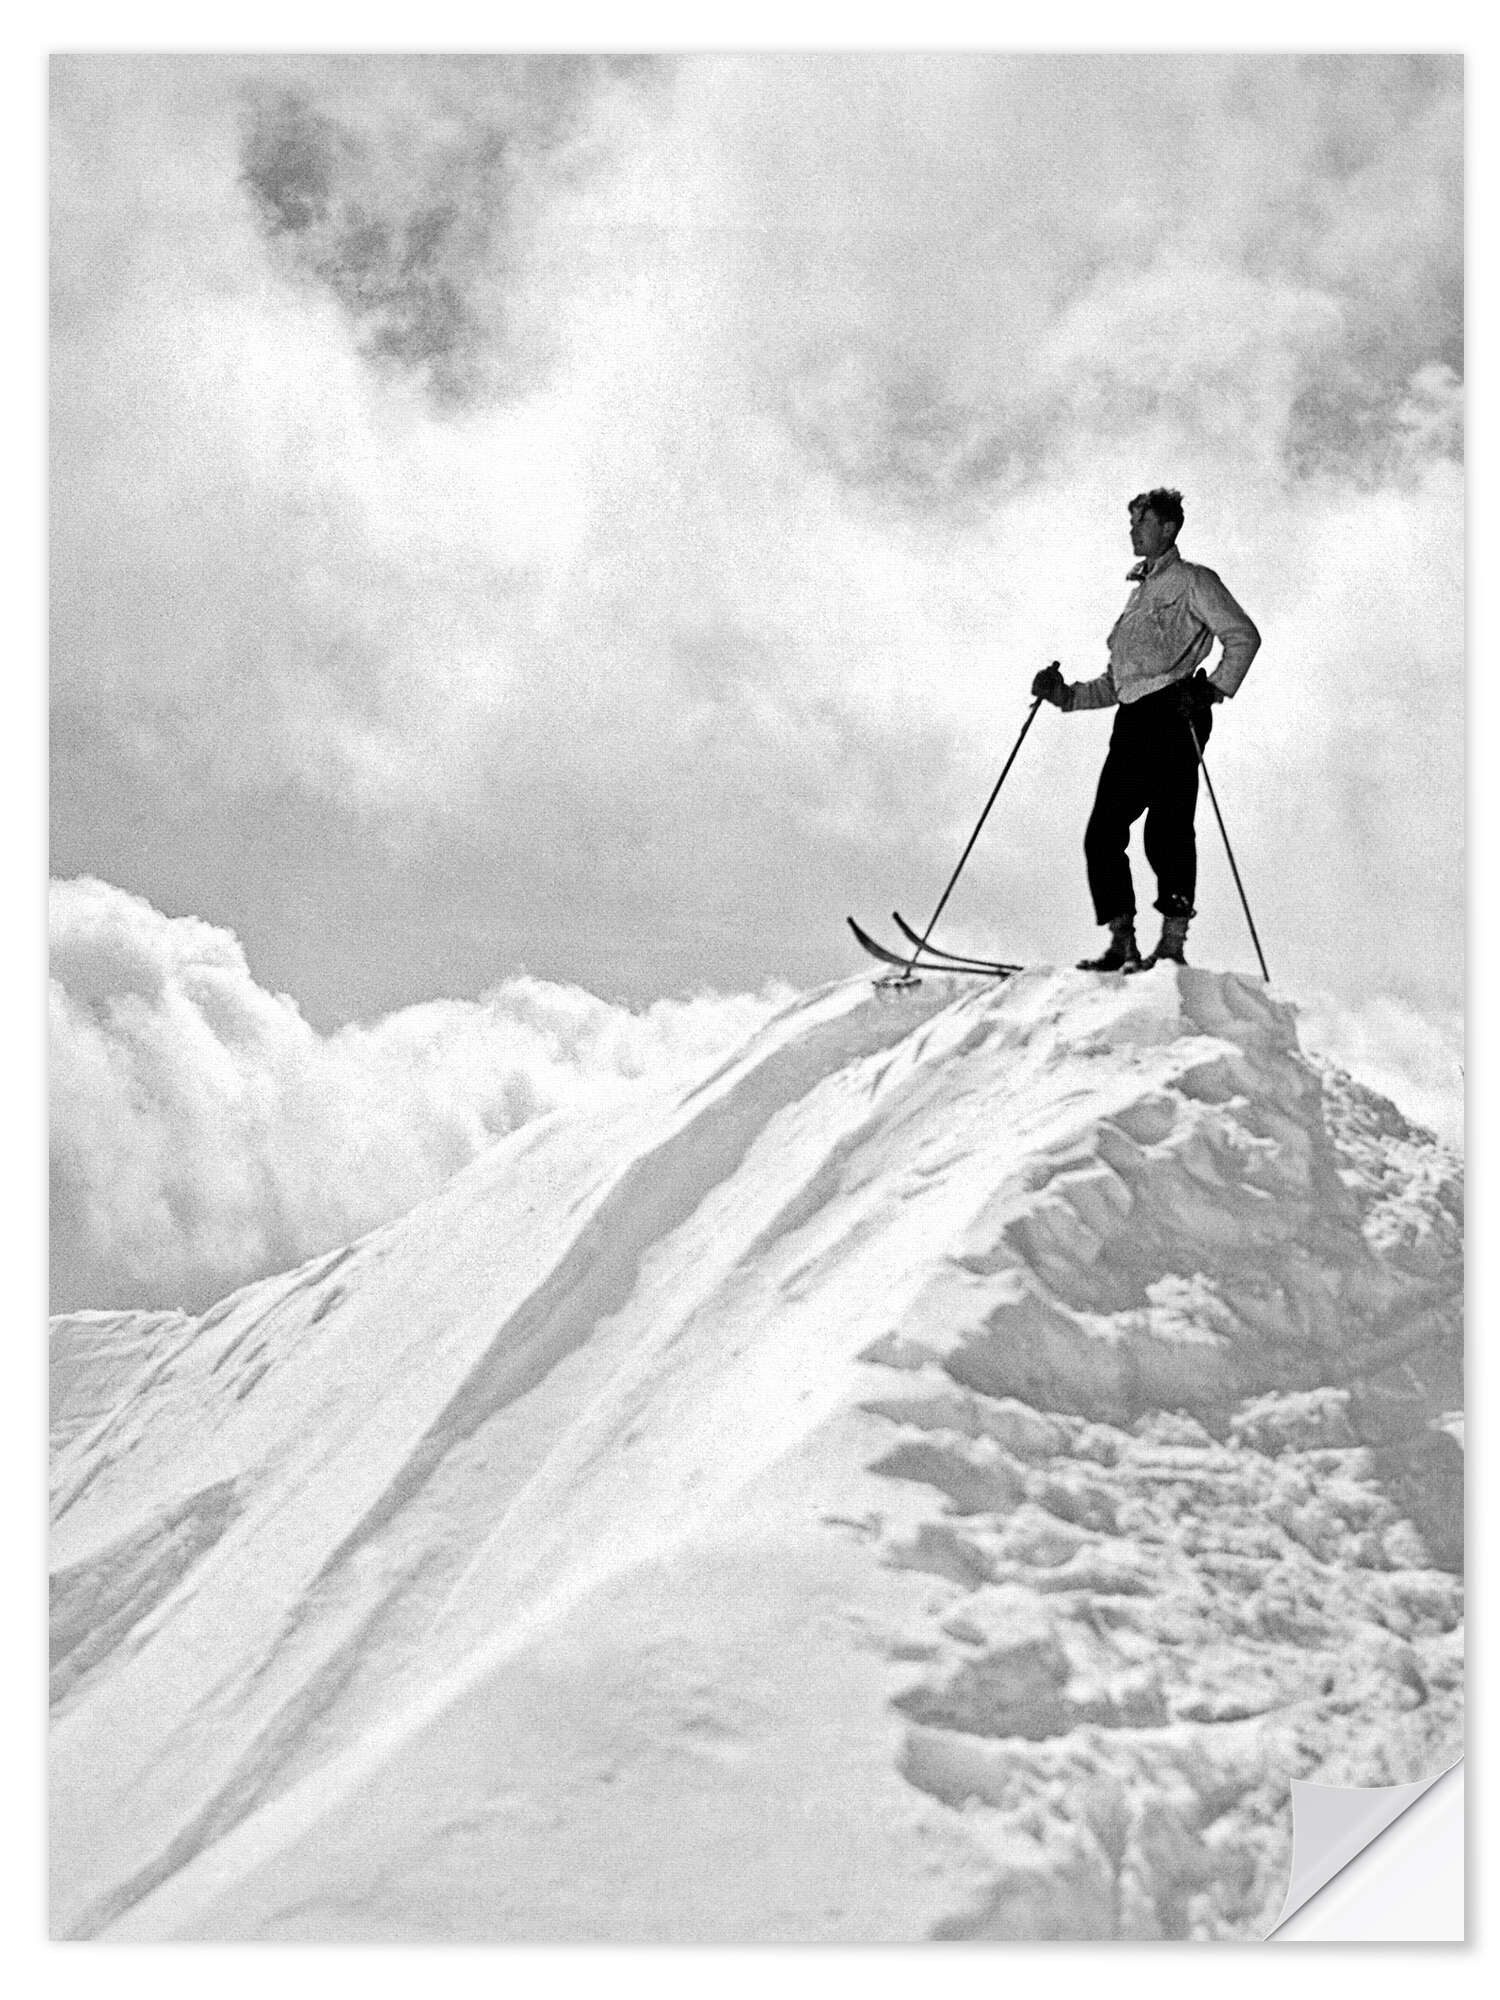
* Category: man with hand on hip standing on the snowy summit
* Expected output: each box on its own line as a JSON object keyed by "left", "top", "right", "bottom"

{"left": 1032, "top": 486, "right": 1260, "bottom": 972}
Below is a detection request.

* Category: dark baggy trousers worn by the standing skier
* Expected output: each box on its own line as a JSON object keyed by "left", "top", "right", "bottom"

{"left": 1084, "top": 682, "right": 1214, "bottom": 924}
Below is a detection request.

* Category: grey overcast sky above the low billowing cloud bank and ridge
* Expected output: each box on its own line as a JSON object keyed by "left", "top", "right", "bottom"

{"left": 52, "top": 54, "right": 1464, "bottom": 1312}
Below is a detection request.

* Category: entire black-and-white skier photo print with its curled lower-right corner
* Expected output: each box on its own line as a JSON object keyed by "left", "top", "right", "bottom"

{"left": 50, "top": 47, "right": 1468, "bottom": 1944}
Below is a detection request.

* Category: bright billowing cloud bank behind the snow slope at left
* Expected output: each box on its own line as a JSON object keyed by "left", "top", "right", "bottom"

{"left": 50, "top": 880, "right": 786, "bottom": 1310}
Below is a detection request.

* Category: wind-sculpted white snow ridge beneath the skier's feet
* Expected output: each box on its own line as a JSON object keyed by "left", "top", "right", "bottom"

{"left": 54, "top": 968, "right": 1462, "bottom": 1944}
